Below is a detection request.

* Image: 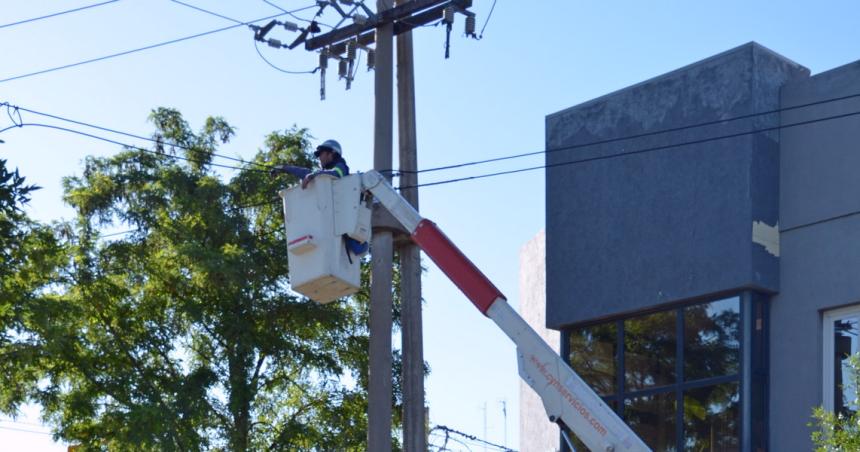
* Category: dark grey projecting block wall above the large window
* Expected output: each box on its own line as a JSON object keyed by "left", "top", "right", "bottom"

{"left": 546, "top": 43, "right": 808, "bottom": 328}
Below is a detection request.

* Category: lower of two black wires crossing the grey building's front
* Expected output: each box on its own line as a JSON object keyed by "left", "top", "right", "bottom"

{"left": 400, "top": 106, "right": 860, "bottom": 190}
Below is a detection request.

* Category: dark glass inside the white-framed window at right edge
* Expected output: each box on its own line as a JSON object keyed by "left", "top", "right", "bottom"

{"left": 833, "top": 316, "right": 860, "bottom": 416}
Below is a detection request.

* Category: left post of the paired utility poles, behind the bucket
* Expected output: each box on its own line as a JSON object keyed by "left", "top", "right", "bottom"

{"left": 367, "top": 0, "right": 394, "bottom": 452}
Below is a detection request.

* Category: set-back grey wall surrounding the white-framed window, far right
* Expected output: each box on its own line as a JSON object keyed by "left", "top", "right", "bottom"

{"left": 770, "top": 62, "right": 860, "bottom": 450}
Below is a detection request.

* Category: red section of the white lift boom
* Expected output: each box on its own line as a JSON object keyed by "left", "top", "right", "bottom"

{"left": 412, "top": 219, "right": 505, "bottom": 315}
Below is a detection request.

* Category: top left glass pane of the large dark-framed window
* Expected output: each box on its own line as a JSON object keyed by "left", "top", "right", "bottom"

{"left": 570, "top": 322, "right": 618, "bottom": 396}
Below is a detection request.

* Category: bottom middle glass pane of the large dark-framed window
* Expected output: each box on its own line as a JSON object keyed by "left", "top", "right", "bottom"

{"left": 624, "top": 392, "right": 677, "bottom": 452}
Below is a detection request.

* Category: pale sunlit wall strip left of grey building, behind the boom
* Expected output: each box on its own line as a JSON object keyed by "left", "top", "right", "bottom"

{"left": 519, "top": 231, "right": 559, "bottom": 452}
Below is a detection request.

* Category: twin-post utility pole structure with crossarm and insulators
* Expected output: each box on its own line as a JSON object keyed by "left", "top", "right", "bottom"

{"left": 284, "top": 0, "right": 477, "bottom": 452}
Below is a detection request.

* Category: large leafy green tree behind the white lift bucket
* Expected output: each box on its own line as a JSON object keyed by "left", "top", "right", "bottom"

{"left": 0, "top": 109, "right": 400, "bottom": 451}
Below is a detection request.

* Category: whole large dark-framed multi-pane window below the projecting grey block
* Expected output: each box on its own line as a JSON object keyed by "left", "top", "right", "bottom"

{"left": 566, "top": 297, "right": 744, "bottom": 452}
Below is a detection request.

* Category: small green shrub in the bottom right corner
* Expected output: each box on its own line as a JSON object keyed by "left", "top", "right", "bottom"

{"left": 809, "top": 354, "right": 860, "bottom": 452}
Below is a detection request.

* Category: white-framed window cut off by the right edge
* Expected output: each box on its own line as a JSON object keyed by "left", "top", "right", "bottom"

{"left": 823, "top": 306, "right": 860, "bottom": 414}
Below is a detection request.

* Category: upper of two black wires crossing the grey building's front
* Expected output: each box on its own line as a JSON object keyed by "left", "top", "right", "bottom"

{"left": 400, "top": 93, "right": 860, "bottom": 174}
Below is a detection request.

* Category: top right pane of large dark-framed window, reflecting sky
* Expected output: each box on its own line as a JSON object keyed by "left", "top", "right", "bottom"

{"left": 684, "top": 298, "right": 741, "bottom": 381}
